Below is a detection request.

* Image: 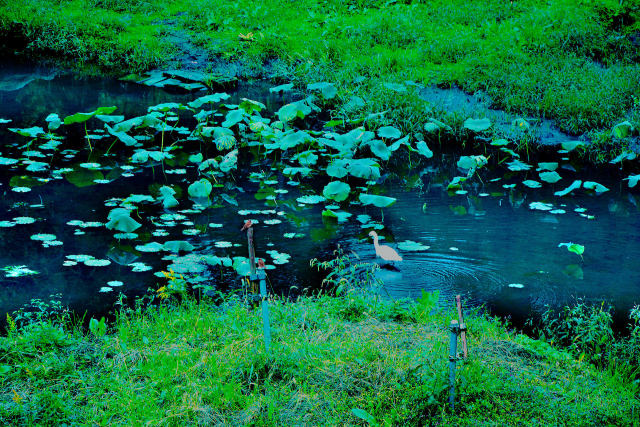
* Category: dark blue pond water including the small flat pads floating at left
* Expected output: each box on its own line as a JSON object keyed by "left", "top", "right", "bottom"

{"left": 0, "top": 65, "right": 640, "bottom": 332}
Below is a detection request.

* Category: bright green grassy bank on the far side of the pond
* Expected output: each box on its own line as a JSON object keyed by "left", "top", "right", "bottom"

{"left": 0, "top": 0, "right": 640, "bottom": 154}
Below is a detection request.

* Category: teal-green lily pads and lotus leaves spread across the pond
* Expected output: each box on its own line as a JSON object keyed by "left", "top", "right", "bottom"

{"left": 0, "top": 82, "right": 640, "bottom": 300}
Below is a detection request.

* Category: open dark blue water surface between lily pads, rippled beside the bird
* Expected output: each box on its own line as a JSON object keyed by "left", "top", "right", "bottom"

{"left": 0, "top": 66, "right": 640, "bottom": 330}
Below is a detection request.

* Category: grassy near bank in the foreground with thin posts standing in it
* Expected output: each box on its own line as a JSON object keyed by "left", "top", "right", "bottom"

{"left": 0, "top": 291, "right": 640, "bottom": 425}
